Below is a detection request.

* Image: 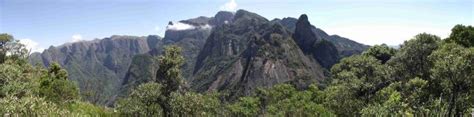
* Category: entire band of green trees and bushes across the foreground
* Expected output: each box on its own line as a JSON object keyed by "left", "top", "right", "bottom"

{"left": 0, "top": 25, "right": 474, "bottom": 116}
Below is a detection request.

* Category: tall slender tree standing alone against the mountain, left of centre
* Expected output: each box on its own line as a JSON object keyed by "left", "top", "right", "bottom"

{"left": 155, "top": 45, "right": 184, "bottom": 116}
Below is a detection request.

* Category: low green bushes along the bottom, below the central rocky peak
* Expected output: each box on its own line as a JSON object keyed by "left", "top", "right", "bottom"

{"left": 228, "top": 84, "right": 333, "bottom": 116}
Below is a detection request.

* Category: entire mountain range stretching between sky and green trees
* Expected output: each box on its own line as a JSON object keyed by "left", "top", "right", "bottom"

{"left": 30, "top": 10, "right": 369, "bottom": 105}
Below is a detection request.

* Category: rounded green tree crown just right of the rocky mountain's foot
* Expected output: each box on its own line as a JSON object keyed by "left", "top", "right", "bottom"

{"left": 331, "top": 55, "right": 392, "bottom": 102}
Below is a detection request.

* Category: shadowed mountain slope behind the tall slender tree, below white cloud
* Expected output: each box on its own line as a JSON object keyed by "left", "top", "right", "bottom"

{"left": 118, "top": 11, "right": 234, "bottom": 96}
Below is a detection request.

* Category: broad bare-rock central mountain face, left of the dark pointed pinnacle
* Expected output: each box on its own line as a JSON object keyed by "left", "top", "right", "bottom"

{"left": 191, "top": 10, "right": 324, "bottom": 97}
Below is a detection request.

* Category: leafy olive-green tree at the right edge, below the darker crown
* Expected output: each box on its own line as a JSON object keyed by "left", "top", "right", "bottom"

{"left": 429, "top": 43, "right": 474, "bottom": 116}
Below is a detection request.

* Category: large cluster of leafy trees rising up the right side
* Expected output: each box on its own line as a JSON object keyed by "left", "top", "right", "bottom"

{"left": 324, "top": 25, "right": 474, "bottom": 116}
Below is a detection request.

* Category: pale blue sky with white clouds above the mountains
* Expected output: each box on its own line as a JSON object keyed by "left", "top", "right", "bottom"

{"left": 0, "top": 0, "right": 474, "bottom": 51}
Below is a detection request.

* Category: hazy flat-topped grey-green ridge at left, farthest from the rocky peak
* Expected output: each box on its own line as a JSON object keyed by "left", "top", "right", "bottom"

{"left": 30, "top": 36, "right": 160, "bottom": 104}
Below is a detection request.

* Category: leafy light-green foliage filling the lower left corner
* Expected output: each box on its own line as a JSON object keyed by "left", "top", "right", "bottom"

{"left": 0, "top": 34, "right": 113, "bottom": 116}
